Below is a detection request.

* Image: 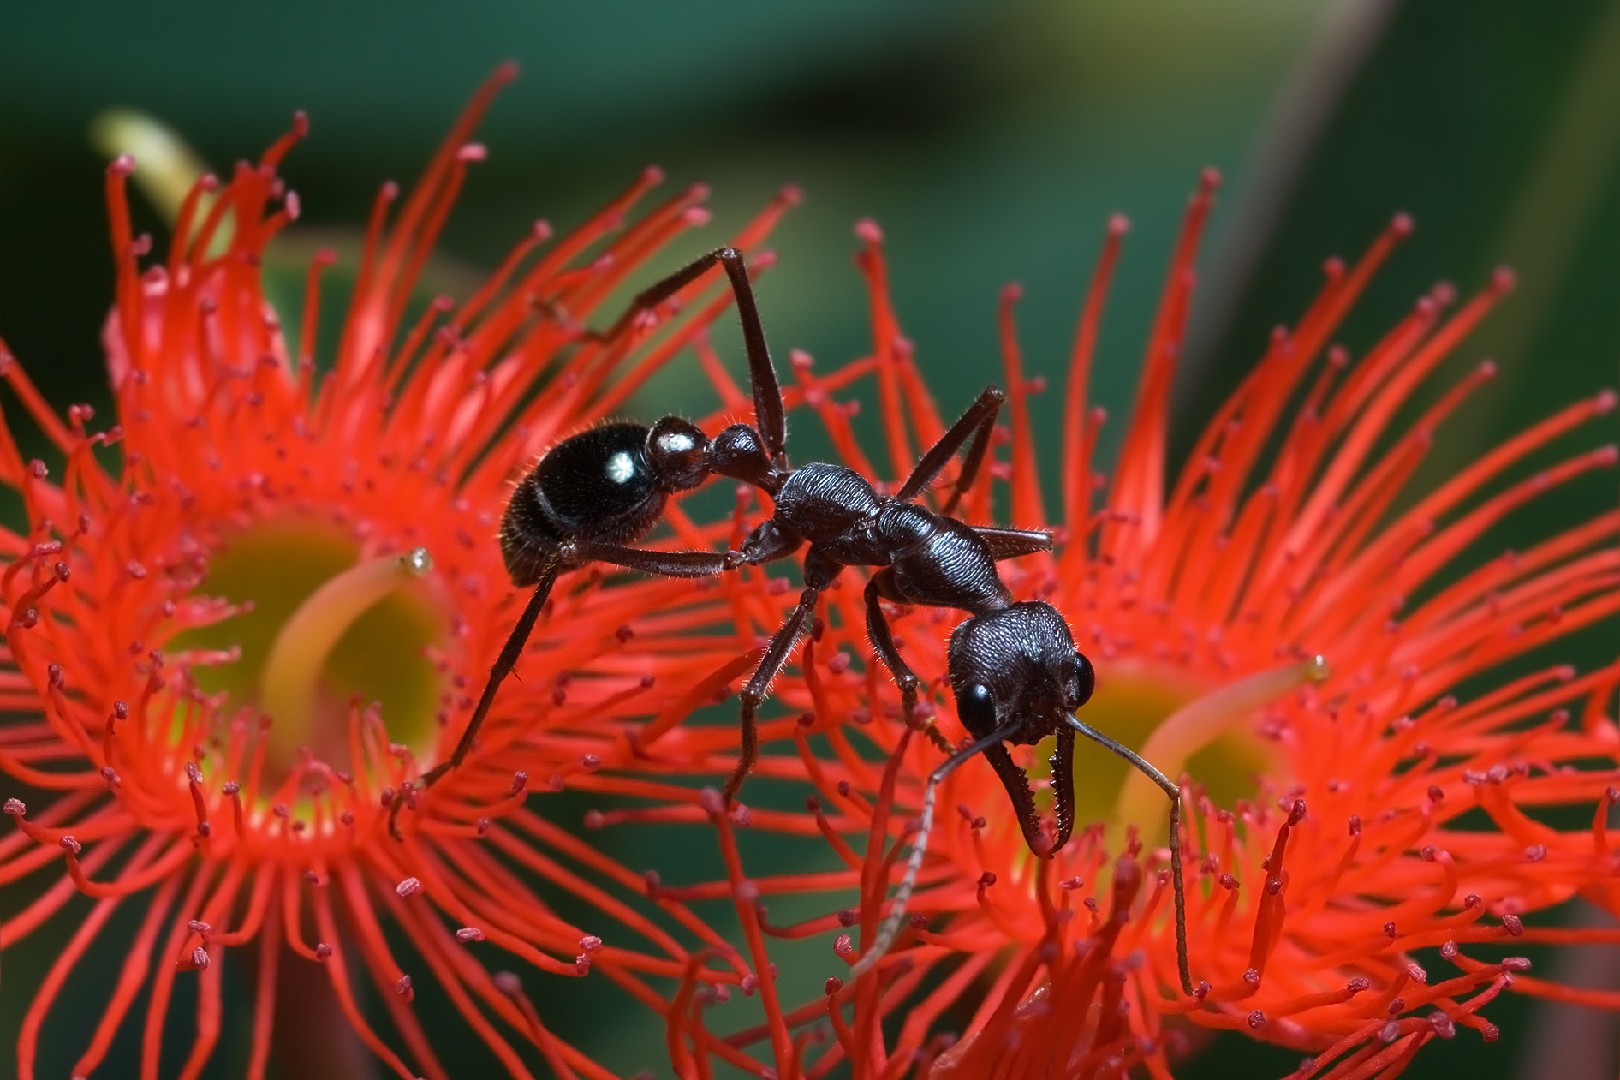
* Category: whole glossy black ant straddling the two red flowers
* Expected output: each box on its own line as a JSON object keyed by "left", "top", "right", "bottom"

{"left": 389, "top": 248, "right": 1192, "bottom": 994}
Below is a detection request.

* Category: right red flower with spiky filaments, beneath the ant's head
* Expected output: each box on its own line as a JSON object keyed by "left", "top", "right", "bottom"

{"left": 657, "top": 178, "right": 1620, "bottom": 1078}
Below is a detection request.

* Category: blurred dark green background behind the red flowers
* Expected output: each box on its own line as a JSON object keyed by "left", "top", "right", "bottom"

{"left": 0, "top": 0, "right": 1620, "bottom": 1080}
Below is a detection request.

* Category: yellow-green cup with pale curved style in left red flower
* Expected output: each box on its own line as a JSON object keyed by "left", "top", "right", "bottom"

{"left": 170, "top": 521, "right": 449, "bottom": 790}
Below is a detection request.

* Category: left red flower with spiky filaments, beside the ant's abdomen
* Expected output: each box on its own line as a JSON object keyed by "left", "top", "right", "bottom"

{"left": 0, "top": 70, "right": 786, "bottom": 1077}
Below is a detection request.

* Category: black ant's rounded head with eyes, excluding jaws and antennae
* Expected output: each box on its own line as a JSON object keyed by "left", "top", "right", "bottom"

{"left": 949, "top": 601, "right": 1097, "bottom": 743}
